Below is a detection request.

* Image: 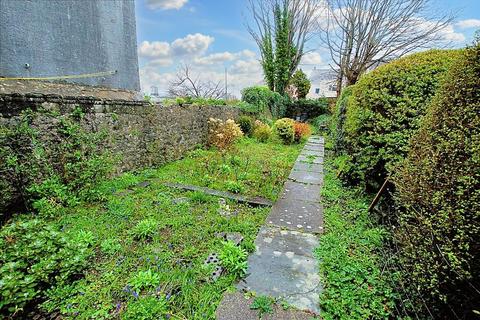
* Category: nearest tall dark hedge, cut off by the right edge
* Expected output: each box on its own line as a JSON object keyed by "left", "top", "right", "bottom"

{"left": 394, "top": 42, "right": 480, "bottom": 319}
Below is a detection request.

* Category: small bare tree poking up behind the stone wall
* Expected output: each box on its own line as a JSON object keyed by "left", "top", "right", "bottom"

{"left": 168, "top": 65, "right": 225, "bottom": 99}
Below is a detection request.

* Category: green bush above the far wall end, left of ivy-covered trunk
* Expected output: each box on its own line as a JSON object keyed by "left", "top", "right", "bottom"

{"left": 242, "top": 86, "right": 290, "bottom": 119}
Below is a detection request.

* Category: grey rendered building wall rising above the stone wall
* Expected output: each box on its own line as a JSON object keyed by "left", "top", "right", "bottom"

{"left": 0, "top": 0, "right": 140, "bottom": 91}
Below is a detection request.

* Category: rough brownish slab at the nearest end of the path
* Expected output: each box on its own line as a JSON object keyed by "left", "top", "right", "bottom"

{"left": 216, "top": 292, "right": 314, "bottom": 320}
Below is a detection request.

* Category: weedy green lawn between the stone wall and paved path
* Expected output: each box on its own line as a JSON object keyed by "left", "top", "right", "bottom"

{"left": 2, "top": 138, "right": 302, "bottom": 319}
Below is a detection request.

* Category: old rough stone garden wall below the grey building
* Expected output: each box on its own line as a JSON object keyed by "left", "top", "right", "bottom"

{"left": 0, "top": 94, "right": 240, "bottom": 171}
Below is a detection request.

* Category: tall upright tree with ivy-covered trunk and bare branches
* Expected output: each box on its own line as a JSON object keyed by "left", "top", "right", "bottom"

{"left": 247, "top": 0, "right": 322, "bottom": 93}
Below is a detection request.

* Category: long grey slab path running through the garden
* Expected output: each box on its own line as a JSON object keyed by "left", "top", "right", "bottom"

{"left": 217, "top": 137, "right": 324, "bottom": 320}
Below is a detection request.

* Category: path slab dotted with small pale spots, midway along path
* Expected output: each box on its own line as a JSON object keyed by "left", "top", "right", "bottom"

{"left": 267, "top": 199, "right": 323, "bottom": 233}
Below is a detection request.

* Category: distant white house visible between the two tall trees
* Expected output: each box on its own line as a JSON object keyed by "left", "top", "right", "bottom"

{"left": 307, "top": 68, "right": 337, "bottom": 99}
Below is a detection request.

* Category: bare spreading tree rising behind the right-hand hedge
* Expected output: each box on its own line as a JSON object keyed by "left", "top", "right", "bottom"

{"left": 319, "top": 0, "right": 453, "bottom": 93}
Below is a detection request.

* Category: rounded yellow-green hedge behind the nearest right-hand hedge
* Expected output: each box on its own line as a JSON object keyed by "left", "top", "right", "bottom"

{"left": 345, "top": 50, "right": 460, "bottom": 191}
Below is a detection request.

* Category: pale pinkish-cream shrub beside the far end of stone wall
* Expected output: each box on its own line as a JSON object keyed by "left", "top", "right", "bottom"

{"left": 208, "top": 118, "right": 243, "bottom": 151}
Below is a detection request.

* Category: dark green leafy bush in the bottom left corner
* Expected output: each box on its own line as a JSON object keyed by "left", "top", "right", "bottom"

{"left": 0, "top": 219, "right": 93, "bottom": 314}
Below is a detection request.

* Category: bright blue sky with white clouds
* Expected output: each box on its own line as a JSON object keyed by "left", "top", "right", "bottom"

{"left": 135, "top": 0, "right": 480, "bottom": 97}
